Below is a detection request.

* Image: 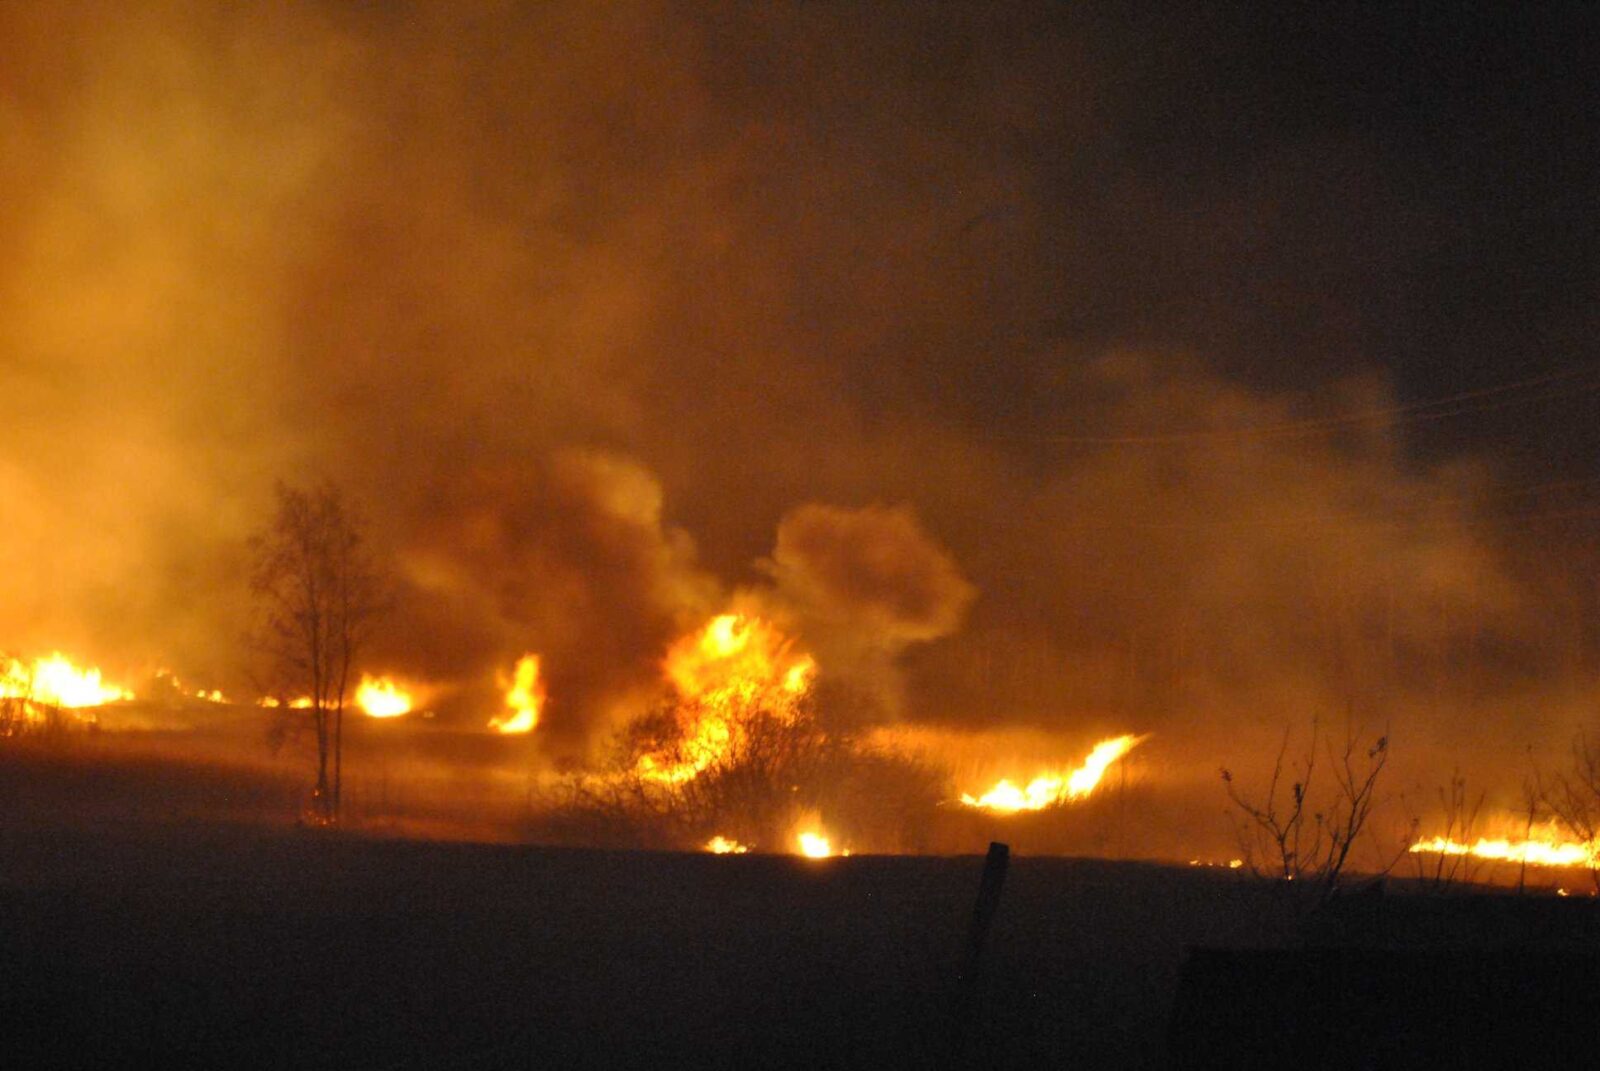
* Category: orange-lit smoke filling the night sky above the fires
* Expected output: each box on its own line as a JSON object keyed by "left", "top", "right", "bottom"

{"left": 0, "top": 3, "right": 1600, "bottom": 784}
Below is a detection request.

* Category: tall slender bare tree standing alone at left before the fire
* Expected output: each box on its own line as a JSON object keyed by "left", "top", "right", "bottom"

{"left": 250, "top": 483, "right": 381, "bottom": 823}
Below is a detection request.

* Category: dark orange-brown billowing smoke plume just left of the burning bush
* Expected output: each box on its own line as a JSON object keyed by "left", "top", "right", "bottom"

{"left": 378, "top": 450, "right": 722, "bottom": 754}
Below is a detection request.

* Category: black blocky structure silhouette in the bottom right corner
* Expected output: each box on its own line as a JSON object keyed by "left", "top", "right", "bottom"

{"left": 1168, "top": 893, "right": 1600, "bottom": 1068}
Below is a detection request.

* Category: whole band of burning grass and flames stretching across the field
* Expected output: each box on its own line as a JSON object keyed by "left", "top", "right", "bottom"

{"left": 9, "top": 563, "right": 1600, "bottom": 897}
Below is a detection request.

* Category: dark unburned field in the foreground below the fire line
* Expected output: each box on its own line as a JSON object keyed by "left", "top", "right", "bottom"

{"left": 15, "top": 740, "right": 1600, "bottom": 1071}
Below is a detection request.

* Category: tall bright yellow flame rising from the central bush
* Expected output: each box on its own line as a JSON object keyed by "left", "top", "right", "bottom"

{"left": 638, "top": 613, "right": 816, "bottom": 783}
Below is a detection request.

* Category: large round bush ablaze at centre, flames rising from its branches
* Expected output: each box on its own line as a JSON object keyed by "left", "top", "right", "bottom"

{"left": 537, "top": 615, "right": 946, "bottom": 850}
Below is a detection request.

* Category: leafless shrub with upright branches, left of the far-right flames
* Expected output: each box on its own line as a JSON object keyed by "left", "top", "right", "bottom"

{"left": 1222, "top": 720, "right": 1392, "bottom": 903}
